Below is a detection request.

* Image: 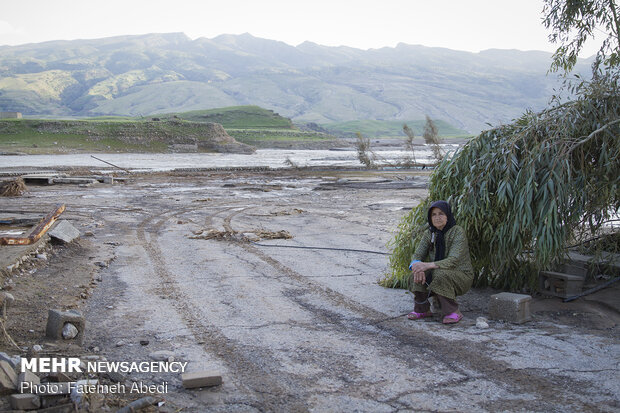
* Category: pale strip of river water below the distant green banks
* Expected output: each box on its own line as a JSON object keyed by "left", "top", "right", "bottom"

{"left": 0, "top": 145, "right": 456, "bottom": 171}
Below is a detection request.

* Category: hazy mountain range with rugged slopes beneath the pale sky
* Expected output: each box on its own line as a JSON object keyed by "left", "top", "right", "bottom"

{"left": 0, "top": 33, "right": 588, "bottom": 133}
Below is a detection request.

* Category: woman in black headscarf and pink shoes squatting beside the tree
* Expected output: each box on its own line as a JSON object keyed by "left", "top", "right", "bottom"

{"left": 407, "top": 201, "right": 474, "bottom": 324}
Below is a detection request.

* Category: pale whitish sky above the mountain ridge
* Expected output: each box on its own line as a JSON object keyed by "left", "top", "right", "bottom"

{"left": 0, "top": 0, "right": 596, "bottom": 57}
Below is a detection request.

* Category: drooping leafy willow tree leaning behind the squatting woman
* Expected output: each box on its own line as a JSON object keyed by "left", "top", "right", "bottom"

{"left": 382, "top": 73, "right": 620, "bottom": 290}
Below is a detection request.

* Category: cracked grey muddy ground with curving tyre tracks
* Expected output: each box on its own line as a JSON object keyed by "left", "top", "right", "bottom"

{"left": 0, "top": 170, "right": 620, "bottom": 412}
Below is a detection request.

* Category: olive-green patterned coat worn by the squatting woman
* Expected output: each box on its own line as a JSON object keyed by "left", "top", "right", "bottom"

{"left": 411, "top": 225, "right": 474, "bottom": 299}
